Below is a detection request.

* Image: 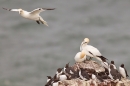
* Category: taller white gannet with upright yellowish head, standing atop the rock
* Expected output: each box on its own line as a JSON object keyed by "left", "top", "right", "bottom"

{"left": 80, "top": 38, "right": 107, "bottom": 61}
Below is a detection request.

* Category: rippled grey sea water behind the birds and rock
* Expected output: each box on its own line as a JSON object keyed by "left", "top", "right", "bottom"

{"left": 0, "top": 0, "right": 130, "bottom": 86}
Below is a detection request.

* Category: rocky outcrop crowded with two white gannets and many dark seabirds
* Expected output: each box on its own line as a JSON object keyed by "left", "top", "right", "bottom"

{"left": 45, "top": 38, "right": 129, "bottom": 86}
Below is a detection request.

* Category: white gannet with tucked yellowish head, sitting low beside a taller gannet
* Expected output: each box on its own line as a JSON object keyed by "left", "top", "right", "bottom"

{"left": 74, "top": 51, "right": 86, "bottom": 62}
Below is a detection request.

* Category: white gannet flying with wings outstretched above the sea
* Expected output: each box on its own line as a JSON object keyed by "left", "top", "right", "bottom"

{"left": 3, "top": 8, "right": 55, "bottom": 26}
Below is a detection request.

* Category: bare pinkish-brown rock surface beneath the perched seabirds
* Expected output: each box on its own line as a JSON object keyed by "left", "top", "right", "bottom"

{"left": 59, "top": 60, "right": 130, "bottom": 86}
